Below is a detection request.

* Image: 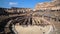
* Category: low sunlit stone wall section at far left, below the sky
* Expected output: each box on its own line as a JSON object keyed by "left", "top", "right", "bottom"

{"left": 6, "top": 8, "right": 32, "bottom": 13}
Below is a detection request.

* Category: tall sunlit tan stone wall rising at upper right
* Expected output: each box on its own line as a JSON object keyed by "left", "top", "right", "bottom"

{"left": 35, "top": 0, "right": 60, "bottom": 10}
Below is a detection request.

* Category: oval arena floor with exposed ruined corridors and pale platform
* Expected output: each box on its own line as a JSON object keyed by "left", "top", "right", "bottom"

{"left": 0, "top": 12, "right": 55, "bottom": 34}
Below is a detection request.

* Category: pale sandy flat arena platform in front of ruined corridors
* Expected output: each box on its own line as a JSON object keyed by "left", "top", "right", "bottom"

{"left": 13, "top": 25, "right": 53, "bottom": 34}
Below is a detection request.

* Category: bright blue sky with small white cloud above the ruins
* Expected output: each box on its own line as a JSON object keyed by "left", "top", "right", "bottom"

{"left": 0, "top": 0, "right": 51, "bottom": 8}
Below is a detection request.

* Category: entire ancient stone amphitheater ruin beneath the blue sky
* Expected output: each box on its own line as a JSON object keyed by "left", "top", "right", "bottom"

{"left": 0, "top": 0, "right": 60, "bottom": 34}
